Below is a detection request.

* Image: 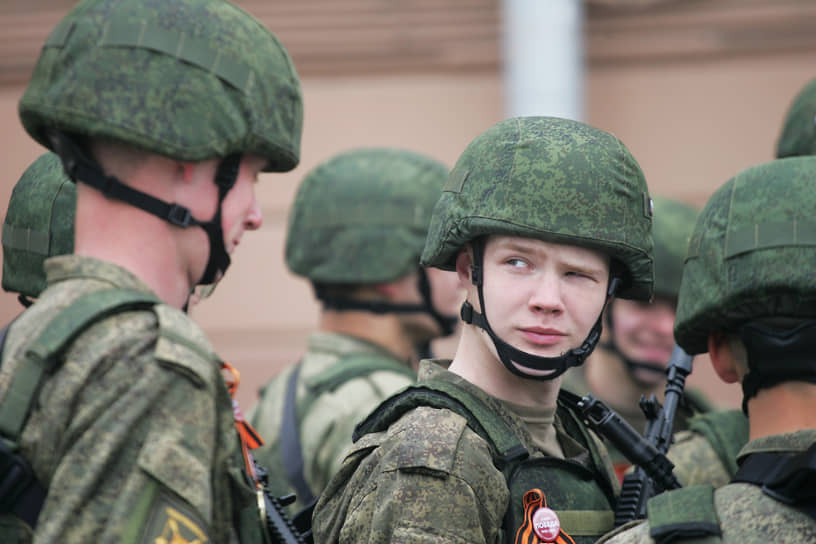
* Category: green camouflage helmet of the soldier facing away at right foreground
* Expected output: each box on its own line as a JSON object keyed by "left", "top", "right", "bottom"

{"left": 674, "top": 157, "right": 816, "bottom": 355}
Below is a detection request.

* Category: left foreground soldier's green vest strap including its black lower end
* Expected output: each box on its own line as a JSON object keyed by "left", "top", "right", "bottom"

{"left": 0, "top": 289, "right": 160, "bottom": 527}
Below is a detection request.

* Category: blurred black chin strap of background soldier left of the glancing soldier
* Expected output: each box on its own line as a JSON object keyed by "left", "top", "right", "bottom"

{"left": 314, "top": 267, "right": 459, "bottom": 336}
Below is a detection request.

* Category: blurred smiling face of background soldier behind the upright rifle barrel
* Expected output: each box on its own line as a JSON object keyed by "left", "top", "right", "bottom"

{"left": 611, "top": 297, "right": 676, "bottom": 383}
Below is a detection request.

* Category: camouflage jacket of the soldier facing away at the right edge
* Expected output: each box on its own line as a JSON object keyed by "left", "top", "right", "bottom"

{"left": 598, "top": 429, "right": 816, "bottom": 544}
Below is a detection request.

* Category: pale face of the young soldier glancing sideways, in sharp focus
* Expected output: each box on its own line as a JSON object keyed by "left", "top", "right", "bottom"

{"left": 468, "top": 236, "right": 609, "bottom": 368}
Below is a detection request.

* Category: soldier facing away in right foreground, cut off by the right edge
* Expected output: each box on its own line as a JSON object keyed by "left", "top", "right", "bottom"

{"left": 596, "top": 157, "right": 816, "bottom": 544}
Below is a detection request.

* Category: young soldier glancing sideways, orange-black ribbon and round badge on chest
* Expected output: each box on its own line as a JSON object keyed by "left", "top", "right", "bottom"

{"left": 314, "top": 117, "right": 653, "bottom": 543}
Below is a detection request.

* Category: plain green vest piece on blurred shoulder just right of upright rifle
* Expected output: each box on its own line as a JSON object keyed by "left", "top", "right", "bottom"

{"left": 689, "top": 410, "right": 748, "bottom": 476}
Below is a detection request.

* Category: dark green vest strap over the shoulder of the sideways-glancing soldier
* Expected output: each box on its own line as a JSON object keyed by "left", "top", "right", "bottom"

{"left": 353, "top": 381, "right": 529, "bottom": 470}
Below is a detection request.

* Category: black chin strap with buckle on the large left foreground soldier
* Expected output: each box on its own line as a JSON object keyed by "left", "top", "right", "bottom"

{"left": 49, "top": 132, "right": 241, "bottom": 285}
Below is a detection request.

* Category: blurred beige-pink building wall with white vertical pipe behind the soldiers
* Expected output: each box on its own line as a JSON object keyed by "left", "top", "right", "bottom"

{"left": 0, "top": 0, "right": 816, "bottom": 406}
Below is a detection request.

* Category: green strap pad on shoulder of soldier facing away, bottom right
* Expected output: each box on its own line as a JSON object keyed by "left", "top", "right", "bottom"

{"left": 646, "top": 485, "right": 722, "bottom": 544}
